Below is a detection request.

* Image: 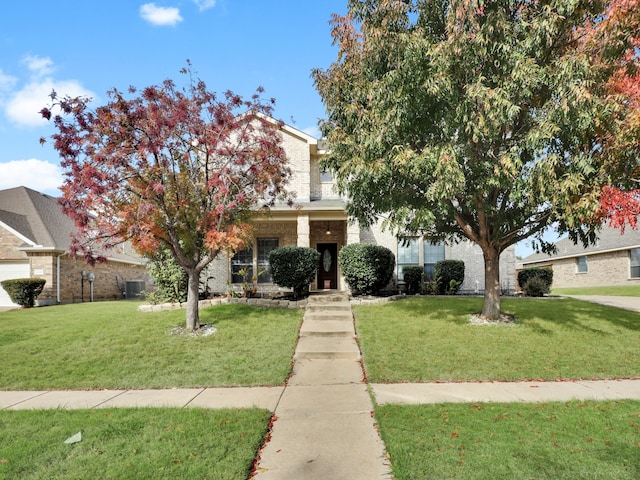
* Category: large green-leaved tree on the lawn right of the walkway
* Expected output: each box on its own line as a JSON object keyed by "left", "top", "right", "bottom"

{"left": 313, "top": 0, "right": 629, "bottom": 318}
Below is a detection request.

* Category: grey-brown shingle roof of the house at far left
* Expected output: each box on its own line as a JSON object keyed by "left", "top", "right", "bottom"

{"left": 0, "top": 187, "right": 144, "bottom": 264}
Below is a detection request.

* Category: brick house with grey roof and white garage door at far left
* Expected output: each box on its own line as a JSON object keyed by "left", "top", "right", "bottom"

{"left": 0, "top": 187, "right": 149, "bottom": 306}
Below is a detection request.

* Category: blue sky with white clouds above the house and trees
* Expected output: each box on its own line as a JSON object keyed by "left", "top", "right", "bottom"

{"left": 0, "top": 0, "right": 552, "bottom": 255}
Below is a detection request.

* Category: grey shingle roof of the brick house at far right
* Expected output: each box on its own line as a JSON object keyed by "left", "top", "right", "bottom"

{"left": 522, "top": 225, "right": 640, "bottom": 265}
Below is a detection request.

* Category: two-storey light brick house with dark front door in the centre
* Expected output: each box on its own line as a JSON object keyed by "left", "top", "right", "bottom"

{"left": 209, "top": 121, "right": 515, "bottom": 293}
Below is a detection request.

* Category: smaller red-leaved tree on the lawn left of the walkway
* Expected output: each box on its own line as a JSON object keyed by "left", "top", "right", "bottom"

{"left": 41, "top": 65, "right": 290, "bottom": 330}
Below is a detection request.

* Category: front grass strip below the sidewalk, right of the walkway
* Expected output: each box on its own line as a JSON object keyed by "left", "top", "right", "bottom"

{"left": 376, "top": 401, "right": 640, "bottom": 480}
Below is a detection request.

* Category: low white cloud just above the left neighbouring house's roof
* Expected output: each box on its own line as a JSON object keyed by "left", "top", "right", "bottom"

{"left": 0, "top": 158, "right": 63, "bottom": 195}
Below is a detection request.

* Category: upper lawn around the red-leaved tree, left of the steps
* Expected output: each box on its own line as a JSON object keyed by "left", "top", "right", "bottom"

{"left": 0, "top": 301, "right": 302, "bottom": 390}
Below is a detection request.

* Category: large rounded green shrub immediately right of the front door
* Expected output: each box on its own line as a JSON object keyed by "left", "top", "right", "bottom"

{"left": 338, "top": 243, "right": 396, "bottom": 295}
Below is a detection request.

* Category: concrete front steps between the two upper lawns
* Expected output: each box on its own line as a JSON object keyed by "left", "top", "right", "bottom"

{"left": 295, "top": 293, "right": 360, "bottom": 360}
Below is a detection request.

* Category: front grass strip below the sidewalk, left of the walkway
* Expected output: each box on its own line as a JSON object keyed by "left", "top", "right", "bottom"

{"left": 0, "top": 408, "right": 270, "bottom": 480}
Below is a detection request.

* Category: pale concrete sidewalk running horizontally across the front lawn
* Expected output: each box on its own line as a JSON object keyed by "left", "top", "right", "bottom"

{"left": 5, "top": 380, "right": 640, "bottom": 412}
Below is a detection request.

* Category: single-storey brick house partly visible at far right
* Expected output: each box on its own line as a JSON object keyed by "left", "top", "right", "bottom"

{"left": 522, "top": 226, "right": 640, "bottom": 288}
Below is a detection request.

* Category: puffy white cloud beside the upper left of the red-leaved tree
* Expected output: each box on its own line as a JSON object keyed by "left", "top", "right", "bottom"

{"left": 5, "top": 78, "right": 94, "bottom": 127}
